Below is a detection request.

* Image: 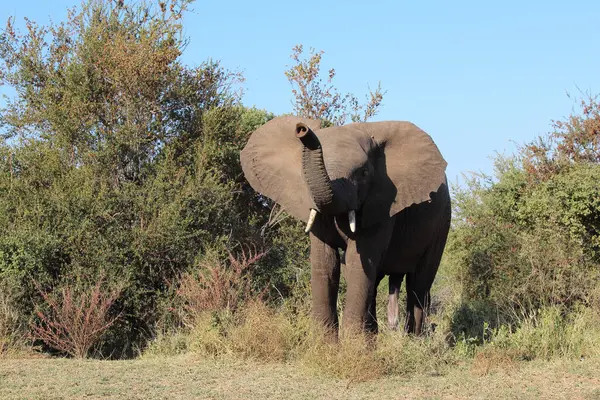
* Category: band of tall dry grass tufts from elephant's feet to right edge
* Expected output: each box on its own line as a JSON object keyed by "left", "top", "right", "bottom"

{"left": 144, "top": 301, "right": 600, "bottom": 382}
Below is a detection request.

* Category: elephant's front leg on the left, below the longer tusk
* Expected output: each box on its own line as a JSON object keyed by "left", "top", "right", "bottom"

{"left": 310, "top": 233, "right": 340, "bottom": 333}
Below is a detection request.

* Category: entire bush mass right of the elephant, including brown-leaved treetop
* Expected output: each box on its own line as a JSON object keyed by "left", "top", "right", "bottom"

{"left": 446, "top": 94, "right": 600, "bottom": 333}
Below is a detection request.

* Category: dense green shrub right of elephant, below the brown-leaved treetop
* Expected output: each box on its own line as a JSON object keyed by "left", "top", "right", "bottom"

{"left": 446, "top": 161, "right": 600, "bottom": 316}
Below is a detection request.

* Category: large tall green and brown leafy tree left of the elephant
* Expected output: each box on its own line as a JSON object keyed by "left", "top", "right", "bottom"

{"left": 0, "top": 0, "right": 272, "bottom": 356}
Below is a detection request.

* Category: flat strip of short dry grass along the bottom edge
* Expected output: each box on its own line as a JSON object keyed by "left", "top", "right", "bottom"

{"left": 0, "top": 355, "right": 600, "bottom": 399}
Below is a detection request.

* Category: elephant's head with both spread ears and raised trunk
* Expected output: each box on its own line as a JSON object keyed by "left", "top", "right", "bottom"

{"left": 240, "top": 116, "right": 446, "bottom": 231}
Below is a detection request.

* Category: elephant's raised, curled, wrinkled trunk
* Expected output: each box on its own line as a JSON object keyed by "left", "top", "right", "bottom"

{"left": 296, "top": 123, "right": 341, "bottom": 214}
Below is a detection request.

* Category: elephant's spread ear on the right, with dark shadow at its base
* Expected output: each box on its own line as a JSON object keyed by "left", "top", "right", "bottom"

{"left": 356, "top": 121, "right": 447, "bottom": 227}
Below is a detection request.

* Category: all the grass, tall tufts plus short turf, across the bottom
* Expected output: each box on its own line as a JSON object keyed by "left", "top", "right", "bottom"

{"left": 0, "top": 288, "right": 600, "bottom": 399}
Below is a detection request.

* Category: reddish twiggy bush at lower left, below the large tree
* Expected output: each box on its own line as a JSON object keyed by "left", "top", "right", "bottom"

{"left": 31, "top": 277, "right": 122, "bottom": 358}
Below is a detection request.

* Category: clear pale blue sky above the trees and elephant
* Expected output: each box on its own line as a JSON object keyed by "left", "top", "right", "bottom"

{"left": 0, "top": 0, "right": 600, "bottom": 183}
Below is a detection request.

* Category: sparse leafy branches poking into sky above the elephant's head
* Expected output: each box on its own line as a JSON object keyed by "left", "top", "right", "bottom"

{"left": 285, "top": 45, "right": 385, "bottom": 125}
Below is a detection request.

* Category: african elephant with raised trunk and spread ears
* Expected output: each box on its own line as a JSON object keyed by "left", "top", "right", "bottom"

{"left": 240, "top": 116, "right": 451, "bottom": 335}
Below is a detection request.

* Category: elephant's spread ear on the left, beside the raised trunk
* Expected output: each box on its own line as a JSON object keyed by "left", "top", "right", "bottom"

{"left": 240, "top": 116, "right": 321, "bottom": 222}
